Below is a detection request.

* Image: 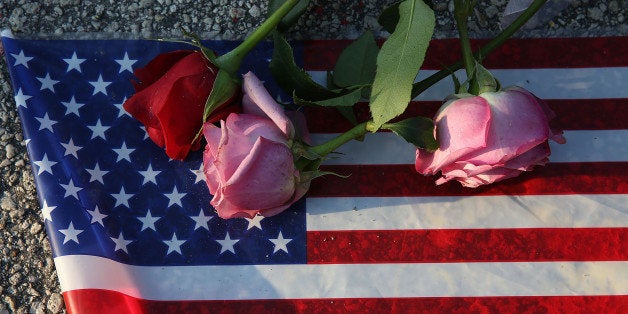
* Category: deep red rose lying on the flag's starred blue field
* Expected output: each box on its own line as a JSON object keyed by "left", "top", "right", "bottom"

{"left": 124, "top": 50, "right": 238, "bottom": 159}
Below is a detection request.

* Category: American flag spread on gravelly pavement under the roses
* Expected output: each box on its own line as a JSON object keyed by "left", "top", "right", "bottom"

{"left": 2, "top": 28, "right": 628, "bottom": 313}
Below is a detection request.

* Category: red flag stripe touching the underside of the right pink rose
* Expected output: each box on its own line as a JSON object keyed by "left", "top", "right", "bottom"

{"left": 308, "top": 162, "right": 628, "bottom": 197}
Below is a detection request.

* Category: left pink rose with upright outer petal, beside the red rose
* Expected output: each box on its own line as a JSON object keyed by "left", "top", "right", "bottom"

{"left": 203, "top": 72, "right": 309, "bottom": 219}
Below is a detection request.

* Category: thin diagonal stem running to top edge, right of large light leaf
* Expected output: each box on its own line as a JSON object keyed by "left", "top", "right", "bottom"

{"left": 412, "top": 0, "right": 547, "bottom": 98}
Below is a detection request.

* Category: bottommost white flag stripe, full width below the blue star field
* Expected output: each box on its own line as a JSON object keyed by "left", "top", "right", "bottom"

{"left": 55, "top": 255, "right": 628, "bottom": 300}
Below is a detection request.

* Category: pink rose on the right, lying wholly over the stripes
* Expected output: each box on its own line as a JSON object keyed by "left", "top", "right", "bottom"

{"left": 415, "top": 87, "right": 565, "bottom": 187}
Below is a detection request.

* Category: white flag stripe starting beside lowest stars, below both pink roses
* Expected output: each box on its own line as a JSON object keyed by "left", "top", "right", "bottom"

{"left": 306, "top": 194, "right": 628, "bottom": 231}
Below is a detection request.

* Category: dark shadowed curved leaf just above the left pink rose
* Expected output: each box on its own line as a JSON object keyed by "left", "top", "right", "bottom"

{"left": 269, "top": 32, "right": 337, "bottom": 100}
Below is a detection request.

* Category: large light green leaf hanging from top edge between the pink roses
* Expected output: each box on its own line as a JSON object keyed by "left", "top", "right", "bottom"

{"left": 370, "top": 0, "right": 435, "bottom": 130}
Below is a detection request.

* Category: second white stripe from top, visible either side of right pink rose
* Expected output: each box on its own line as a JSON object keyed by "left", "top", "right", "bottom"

{"left": 312, "top": 130, "right": 628, "bottom": 165}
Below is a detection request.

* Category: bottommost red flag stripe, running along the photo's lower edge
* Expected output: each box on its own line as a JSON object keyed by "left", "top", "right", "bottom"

{"left": 63, "top": 290, "right": 628, "bottom": 314}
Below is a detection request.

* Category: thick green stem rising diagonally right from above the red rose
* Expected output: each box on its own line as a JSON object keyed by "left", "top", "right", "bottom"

{"left": 213, "top": 0, "right": 300, "bottom": 73}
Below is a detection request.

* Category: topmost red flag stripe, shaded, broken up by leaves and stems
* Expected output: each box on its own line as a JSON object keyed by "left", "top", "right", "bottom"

{"left": 303, "top": 37, "right": 628, "bottom": 71}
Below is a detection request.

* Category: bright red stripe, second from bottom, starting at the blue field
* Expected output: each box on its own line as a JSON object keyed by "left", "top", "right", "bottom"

{"left": 307, "top": 227, "right": 628, "bottom": 264}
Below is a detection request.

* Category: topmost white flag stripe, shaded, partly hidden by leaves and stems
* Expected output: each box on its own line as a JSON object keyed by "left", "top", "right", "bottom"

{"left": 308, "top": 67, "right": 628, "bottom": 100}
